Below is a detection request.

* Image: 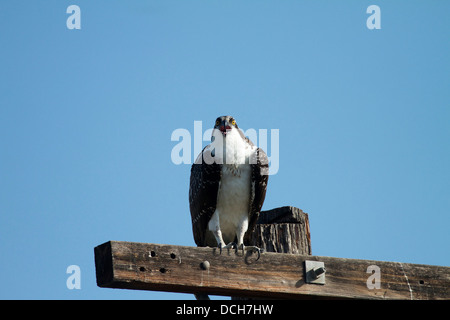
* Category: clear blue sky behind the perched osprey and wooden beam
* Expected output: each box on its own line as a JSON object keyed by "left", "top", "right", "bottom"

{"left": 0, "top": 0, "right": 450, "bottom": 299}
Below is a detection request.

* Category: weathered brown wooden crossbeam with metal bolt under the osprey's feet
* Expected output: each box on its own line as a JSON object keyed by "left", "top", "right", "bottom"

{"left": 94, "top": 241, "right": 450, "bottom": 300}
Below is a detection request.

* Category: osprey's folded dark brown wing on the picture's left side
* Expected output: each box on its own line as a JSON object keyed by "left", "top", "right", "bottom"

{"left": 189, "top": 146, "right": 222, "bottom": 247}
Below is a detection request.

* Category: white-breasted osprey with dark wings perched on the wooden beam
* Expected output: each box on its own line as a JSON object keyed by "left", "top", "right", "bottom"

{"left": 189, "top": 116, "right": 269, "bottom": 258}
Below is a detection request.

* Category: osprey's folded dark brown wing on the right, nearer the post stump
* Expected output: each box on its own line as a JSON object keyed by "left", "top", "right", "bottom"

{"left": 244, "top": 148, "right": 269, "bottom": 244}
